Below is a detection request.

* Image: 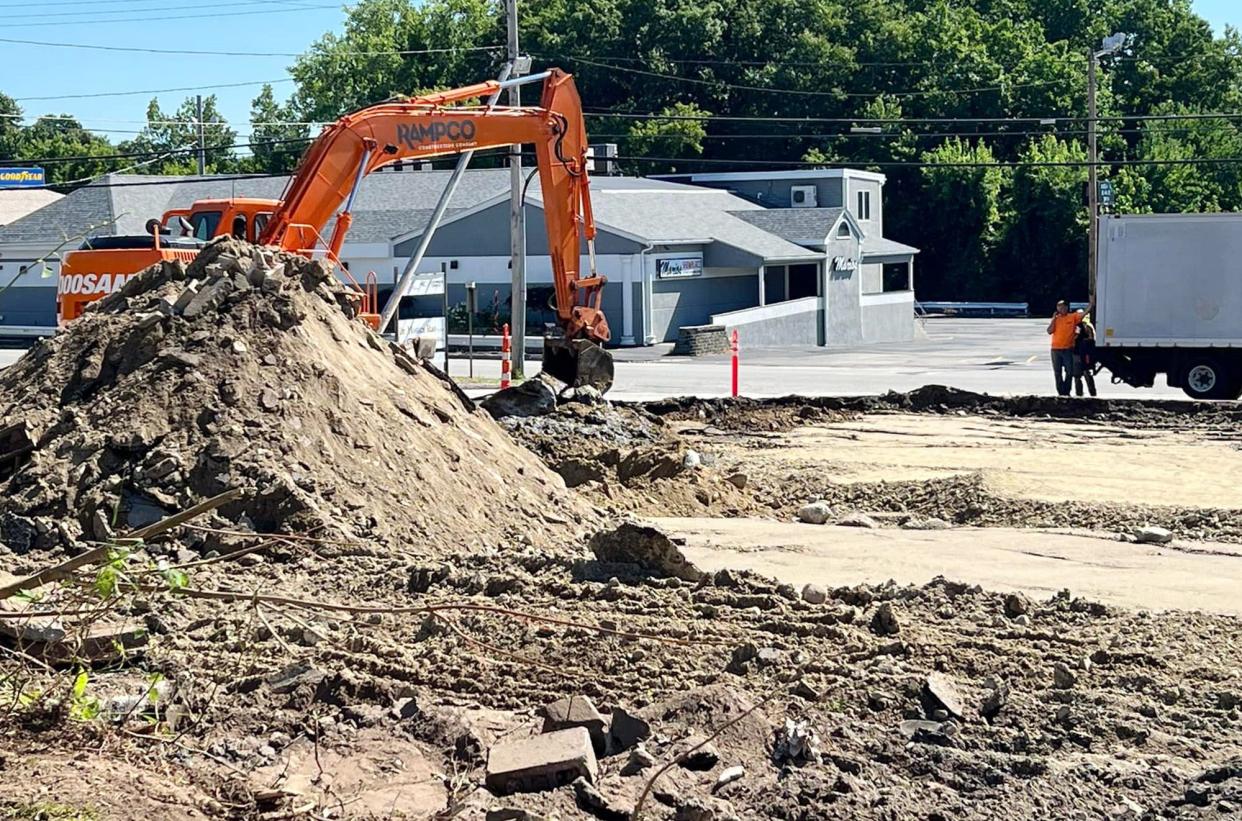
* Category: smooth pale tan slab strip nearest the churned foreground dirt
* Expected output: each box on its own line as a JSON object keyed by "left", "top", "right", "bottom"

{"left": 652, "top": 518, "right": 1242, "bottom": 615}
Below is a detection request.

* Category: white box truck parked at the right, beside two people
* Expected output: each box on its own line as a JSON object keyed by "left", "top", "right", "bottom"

{"left": 1095, "top": 214, "right": 1242, "bottom": 399}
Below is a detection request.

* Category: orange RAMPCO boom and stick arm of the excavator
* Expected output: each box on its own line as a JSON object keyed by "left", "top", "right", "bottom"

{"left": 260, "top": 68, "right": 612, "bottom": 365}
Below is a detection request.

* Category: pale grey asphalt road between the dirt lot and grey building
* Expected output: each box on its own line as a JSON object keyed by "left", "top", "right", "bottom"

{"left": 0, "top": 319, "right": 1184, "bottom": 400}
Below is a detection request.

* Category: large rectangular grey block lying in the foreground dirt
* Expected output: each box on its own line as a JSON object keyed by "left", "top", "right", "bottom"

{"left": 487, "top": 727, "right": 597, "bottom": 795}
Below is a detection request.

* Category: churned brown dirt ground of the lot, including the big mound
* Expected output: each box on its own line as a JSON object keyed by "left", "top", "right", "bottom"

{"left": 0, "top": 248, "right": 1242, "bottom": 821}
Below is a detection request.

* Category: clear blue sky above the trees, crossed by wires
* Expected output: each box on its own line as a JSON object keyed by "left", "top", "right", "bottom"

{"left": 0, "top": 0, "right": 1242, "bottom": 147}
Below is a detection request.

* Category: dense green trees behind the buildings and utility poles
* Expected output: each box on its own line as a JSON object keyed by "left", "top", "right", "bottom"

{"left": 0, "top": 0, "right": 1242, "bottom": 307}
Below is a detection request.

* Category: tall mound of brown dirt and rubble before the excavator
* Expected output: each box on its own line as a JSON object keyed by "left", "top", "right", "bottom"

{"left": 0, "top": 238, "right": 584, "bottom": 555}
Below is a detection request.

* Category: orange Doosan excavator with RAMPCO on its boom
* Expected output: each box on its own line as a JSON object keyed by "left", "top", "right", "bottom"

{"left": 57, "top": 68, "right": 612, "bottom": 390}
